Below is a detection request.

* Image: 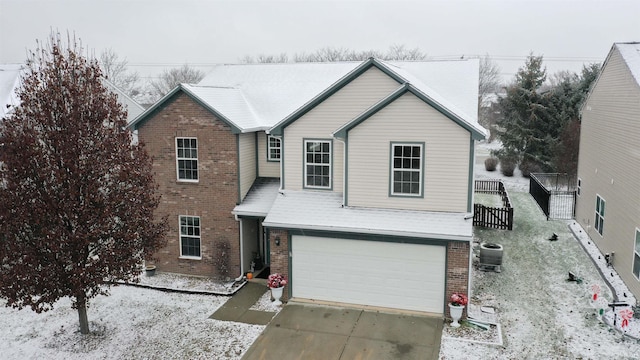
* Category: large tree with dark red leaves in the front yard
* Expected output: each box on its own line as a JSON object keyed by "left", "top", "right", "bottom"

{"left": 0, "top": 34, "right": 166, "bottom": 334}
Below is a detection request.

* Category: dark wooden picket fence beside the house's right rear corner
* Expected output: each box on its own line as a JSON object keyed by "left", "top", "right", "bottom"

{"left": 473, "top": 180, "right": 513, "bottom": 230}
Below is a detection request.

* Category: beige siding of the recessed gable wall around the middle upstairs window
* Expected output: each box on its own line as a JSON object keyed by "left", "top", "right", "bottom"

{"left": 284, "top": 68, "right": 399, "bottom": 192}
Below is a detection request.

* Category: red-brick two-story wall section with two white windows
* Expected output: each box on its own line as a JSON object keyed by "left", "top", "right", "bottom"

{"left": 138, "top": 92, "right": 240, "bottom": 277}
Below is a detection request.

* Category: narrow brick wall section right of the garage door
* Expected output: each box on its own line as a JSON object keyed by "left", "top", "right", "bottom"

{"left": 445, "top": 241, "right": 471, "bottom": 318}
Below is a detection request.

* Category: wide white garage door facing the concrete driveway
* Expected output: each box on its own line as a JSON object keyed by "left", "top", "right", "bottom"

{"left": 291, "top": 235, "right": 446, "bottom": 314}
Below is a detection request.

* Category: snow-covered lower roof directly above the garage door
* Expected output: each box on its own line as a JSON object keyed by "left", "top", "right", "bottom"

{"left": 263, "top": 191, "right": 472, "bottom": 241}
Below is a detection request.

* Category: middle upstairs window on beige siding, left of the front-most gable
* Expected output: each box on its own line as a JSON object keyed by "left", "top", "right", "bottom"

{"left": 304, "top": 140, "right": 331, "bottom": 189}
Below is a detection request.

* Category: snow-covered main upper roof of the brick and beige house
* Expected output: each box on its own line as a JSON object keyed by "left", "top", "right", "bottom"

{"left": 130, "top": 58, "right": 484, "bottom": 135}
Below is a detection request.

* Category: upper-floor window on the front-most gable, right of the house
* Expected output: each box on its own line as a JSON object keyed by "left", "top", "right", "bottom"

{"left": 391, "top": 144, "right": 424, "bottom": 196}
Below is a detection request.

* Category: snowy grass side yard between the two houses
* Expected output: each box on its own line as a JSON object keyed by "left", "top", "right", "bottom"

{"left": 440, "top": 194, "right": 640, "bottom": 360}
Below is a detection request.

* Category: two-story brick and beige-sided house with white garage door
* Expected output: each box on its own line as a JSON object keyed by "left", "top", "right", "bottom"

{"left": 131, "top": 59, "right": 485, "bottom": 314}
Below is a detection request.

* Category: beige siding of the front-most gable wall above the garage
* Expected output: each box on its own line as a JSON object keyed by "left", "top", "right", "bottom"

{"left": 347, "top": 93, "right": 470, "bottom": 212}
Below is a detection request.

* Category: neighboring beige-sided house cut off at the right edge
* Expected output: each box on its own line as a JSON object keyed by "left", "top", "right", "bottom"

{"left": 576, "top": 42, "right": 640, "bottom": 301}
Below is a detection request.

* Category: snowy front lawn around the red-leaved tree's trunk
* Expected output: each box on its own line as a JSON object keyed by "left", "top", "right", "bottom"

{"left": 0, "top": 286, "right": 264, "bottom": 359}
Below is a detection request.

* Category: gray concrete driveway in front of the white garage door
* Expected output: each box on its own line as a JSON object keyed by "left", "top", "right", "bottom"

{"left": 242, "top": 303, "right": 443, "bottom": 360}
